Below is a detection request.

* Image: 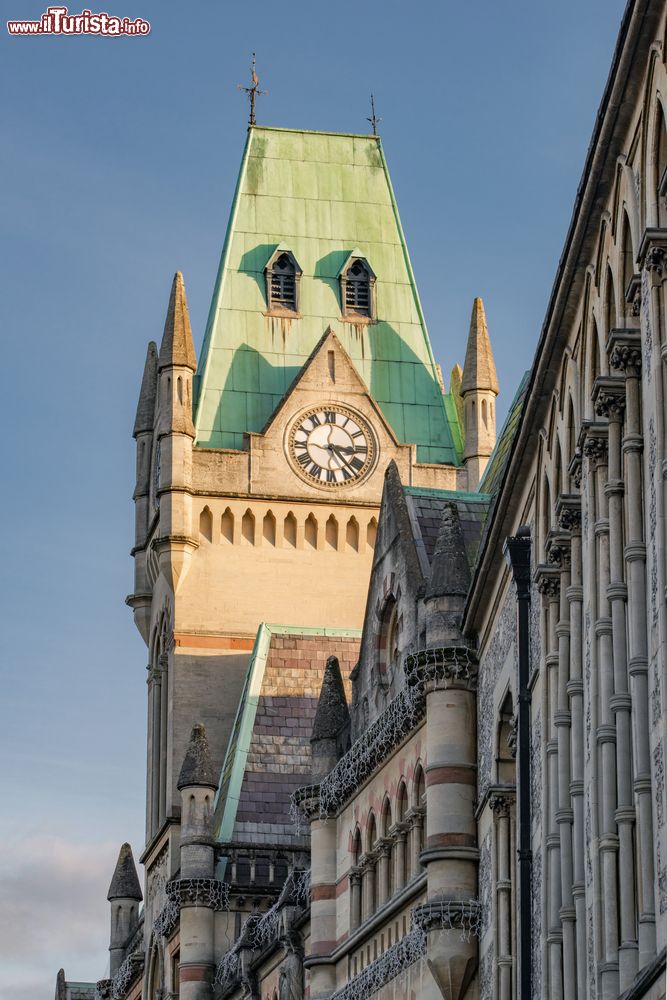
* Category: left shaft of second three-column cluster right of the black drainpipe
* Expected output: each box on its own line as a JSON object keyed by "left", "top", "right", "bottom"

{"left": 583, "top": 423, "right": 619, "bottom": 1000}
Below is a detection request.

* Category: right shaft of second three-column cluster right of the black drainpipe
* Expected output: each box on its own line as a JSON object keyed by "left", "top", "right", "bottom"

{"left": 610, "top": 330, "right": 656, "bottom": 968}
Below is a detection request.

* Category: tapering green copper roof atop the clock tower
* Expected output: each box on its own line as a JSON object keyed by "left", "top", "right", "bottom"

{"left": 195, "top": 127, "right": 462, "bottom": 463}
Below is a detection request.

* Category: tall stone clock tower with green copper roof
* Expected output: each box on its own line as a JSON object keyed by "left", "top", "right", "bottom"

{"left": 128, "top": 126, "right": 480, "bottom": 868}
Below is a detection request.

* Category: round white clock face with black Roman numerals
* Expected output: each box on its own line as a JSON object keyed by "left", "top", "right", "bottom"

{"left": 288, "top": 404, "right": 377, "bottom": 489}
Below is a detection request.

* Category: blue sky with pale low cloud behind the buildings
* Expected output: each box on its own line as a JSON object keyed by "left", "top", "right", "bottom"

{"left": 0, "top": 0, "right": 623, "bottom": 1000}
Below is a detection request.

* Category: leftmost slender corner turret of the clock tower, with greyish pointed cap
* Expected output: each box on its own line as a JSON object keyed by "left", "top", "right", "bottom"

{"left": 130, "top": 341, "right": 157, "bottom": 643}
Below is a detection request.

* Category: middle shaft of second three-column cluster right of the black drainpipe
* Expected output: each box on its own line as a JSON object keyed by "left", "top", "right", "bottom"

{"left": 594, "top": 377, "right": 637, "bottom": 991}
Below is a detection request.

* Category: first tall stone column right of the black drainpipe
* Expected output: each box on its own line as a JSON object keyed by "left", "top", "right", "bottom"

{"left": 535, "top": 565, "right": 563, "bottom": 1000}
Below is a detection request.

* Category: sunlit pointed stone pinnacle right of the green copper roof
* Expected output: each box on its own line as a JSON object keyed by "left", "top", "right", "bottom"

{"left": 461, "top": 298, "right": 500, "bottom": 490}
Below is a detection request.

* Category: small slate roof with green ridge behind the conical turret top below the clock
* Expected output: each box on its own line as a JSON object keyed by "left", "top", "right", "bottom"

{"left": 403, "top": 486, "right": 491, "bottom": 572}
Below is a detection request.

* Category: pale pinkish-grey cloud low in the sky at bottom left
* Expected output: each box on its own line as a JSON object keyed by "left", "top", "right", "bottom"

{"left": 0, "top": 836, "right": 138, "bottom": 1000}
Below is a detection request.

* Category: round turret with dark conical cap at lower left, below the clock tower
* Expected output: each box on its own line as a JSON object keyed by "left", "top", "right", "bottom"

{"left": 178, "top": 722, "right": 219, "bottom": 1000}
